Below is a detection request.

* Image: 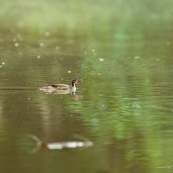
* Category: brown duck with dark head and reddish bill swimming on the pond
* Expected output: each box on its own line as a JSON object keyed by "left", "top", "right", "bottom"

{"left": 39, "top": 79, "right": 82, "bottom": 94}
